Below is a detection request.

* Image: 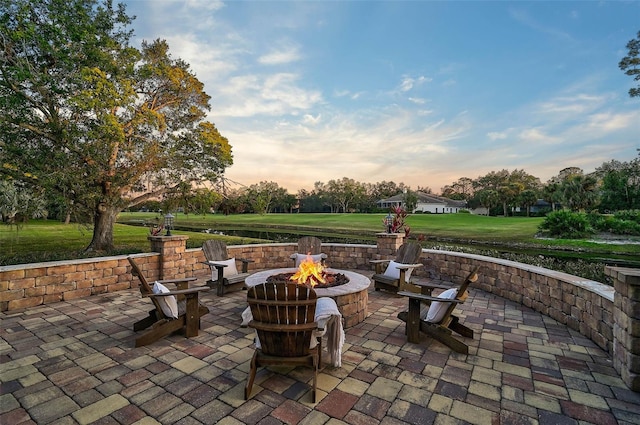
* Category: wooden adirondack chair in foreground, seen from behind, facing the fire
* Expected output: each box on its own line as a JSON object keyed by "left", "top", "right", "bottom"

{"left": 244, "top": 282, "right": 322, "bottom": 403}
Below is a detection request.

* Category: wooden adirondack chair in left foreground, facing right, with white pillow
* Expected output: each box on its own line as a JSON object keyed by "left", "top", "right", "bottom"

{"left": 128, "top": 257, "right": 210, "bottom": 347}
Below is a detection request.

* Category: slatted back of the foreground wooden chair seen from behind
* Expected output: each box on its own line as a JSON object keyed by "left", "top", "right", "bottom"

{"left": 247, "top": 282, "right": 317, "bottom": 357}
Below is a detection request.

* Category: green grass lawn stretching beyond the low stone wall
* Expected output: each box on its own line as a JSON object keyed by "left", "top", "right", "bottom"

{"left": 0, "top": 213, "right": 640, "bottom": 265}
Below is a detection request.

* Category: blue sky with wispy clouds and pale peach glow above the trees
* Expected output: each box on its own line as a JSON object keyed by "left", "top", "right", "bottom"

{"left": 124, "top": 0, "right": 640, "bottom": 194}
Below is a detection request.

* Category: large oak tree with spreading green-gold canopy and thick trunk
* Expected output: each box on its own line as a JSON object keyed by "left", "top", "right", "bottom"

{"left": 0, "top": 0, "right": 232, "bottom": 250}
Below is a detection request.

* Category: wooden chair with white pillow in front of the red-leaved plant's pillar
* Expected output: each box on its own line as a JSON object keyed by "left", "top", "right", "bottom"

{"left": 370, "top": 242, "right": 422, "bottom": 292}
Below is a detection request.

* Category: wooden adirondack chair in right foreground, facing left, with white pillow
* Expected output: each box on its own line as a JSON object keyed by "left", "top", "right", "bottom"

{"left": 398, "top": 267, "right": 479, "bottom": 354}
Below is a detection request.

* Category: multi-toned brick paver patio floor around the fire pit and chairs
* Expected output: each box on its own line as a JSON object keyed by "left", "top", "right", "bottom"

{"left": 0, "top": 272, "right": 640, "bottom": 425}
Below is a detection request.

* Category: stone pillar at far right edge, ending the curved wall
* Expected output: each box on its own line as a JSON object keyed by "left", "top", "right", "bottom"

{"left": 605, "top": 267, "right": 640, "bottom": 392}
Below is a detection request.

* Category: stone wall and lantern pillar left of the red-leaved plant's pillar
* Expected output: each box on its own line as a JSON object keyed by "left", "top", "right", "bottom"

{"left": 0, "top": 236, "right": 378, "bottom": 311}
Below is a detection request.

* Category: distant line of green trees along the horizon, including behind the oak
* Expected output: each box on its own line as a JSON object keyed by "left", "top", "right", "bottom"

{"left": 0, "top": 154, "right": 640, "bottom": 222}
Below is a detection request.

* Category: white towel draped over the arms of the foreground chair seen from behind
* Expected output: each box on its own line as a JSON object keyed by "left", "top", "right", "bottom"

{"left": 241, "top": 297, "right": 345, "bottom": 367}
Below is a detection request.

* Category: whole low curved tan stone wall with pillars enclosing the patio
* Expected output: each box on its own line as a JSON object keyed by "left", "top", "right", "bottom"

{"left": 0, "top": 233, "right": 640, "bottom": 392}
